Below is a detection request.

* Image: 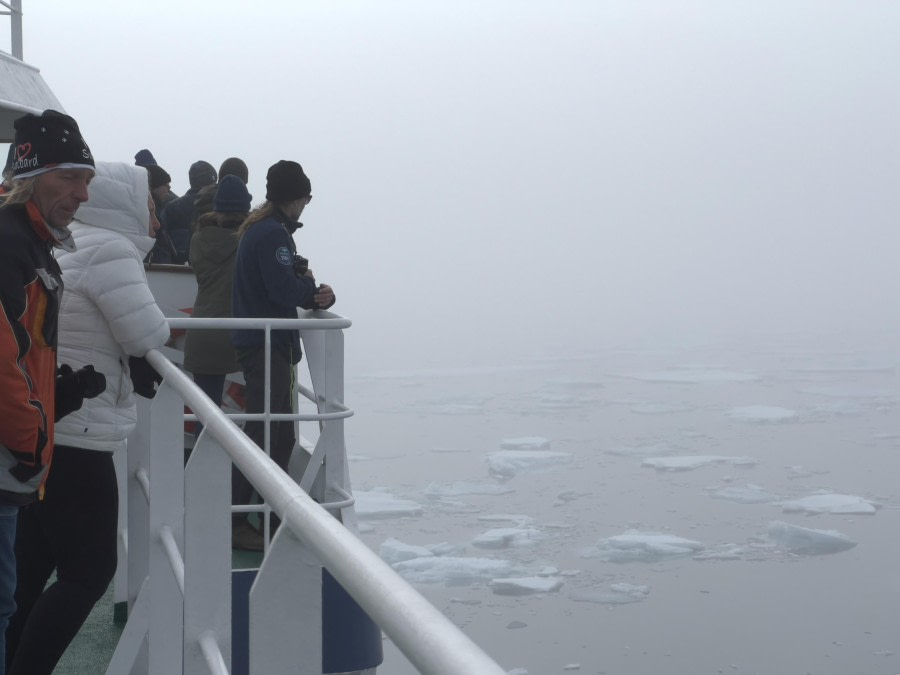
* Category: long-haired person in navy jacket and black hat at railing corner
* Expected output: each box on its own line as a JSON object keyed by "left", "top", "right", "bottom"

{"left": 232, "top": 160, "right": 335, "bottom": 550}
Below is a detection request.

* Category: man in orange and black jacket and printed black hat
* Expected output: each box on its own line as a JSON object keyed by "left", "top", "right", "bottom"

{"left": 0, "top": 110, "right": 106, "bottom": 670}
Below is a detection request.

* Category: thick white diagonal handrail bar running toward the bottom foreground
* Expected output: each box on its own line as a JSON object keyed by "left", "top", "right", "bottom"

{"left": 147, "top": 348, "right": 506, "bottom": 675}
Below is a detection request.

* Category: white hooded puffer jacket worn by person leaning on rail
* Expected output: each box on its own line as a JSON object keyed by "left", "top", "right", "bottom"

{"left": 56, "top": 162, "right": 169, "bottom": 452}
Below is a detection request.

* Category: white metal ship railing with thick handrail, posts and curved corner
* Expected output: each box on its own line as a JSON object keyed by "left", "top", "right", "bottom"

{"left": 107, "top": 312, "right": 505, "bottom": 675}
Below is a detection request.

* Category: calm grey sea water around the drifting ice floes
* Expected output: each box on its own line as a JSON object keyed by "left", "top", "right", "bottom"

{"left": 346, "top": 339, "right": 900, "bottom": 675}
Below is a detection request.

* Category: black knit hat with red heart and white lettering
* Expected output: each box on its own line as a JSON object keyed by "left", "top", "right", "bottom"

{"left": 9, "top": 110, "right": 94, "bottom": 178}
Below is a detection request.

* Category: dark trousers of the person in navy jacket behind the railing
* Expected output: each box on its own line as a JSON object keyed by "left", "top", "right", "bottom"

{"left": 231, "top": 346, "right": 297, "bottom": 518}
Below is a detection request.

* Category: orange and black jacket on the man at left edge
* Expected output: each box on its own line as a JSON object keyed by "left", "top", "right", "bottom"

{"left": 0, "top": 201, "right": 63, "bottom": 504}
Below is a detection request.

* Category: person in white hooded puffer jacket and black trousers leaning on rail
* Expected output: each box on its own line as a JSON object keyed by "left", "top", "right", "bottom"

{"left": 7, "top": 162, "right": 169, "bottom": 675}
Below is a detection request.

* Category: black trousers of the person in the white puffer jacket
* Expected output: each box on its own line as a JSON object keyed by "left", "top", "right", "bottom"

{"left": 6, "top": 445, "right": 119, "bottom": 675}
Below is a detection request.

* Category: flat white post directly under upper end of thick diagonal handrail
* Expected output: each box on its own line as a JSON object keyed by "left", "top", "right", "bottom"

{"left": 149, "top": 381, "right": 184, "bottom": 675}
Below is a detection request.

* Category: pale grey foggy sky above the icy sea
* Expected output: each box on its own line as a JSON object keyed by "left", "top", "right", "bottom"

{"left": 7, "top": 0, "right": 900, "bottom": 370}
